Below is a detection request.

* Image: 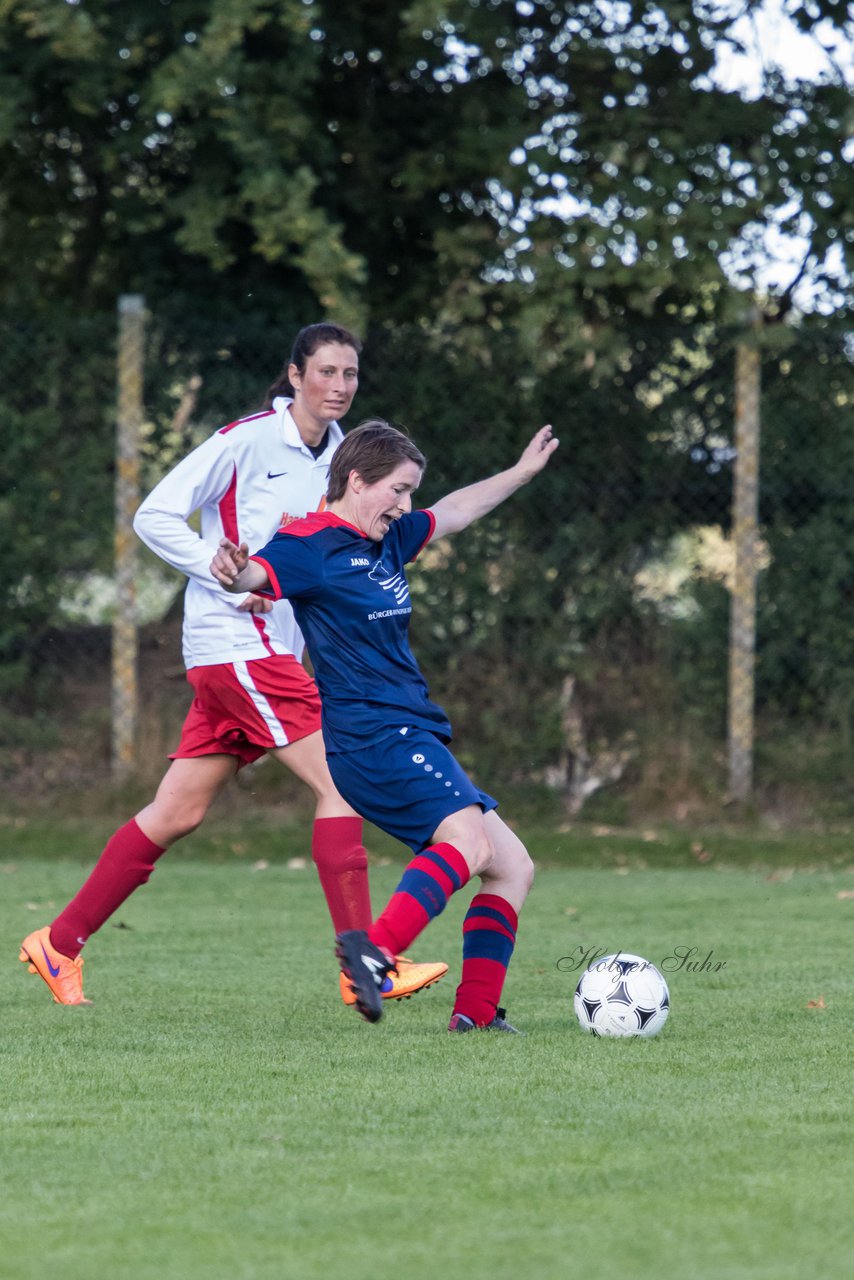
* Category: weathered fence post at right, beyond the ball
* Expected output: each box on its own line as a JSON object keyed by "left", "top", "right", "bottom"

{"left": 727, "top": 312, "right": 761, "bottom": 801}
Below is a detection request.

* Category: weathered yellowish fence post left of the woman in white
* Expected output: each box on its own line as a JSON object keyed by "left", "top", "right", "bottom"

{"left": 111, "top": 293, "right": 145, "bottom": 780}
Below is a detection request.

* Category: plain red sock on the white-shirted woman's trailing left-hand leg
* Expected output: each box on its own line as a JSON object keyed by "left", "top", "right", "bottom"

{"left": 50, "top": 818, "right": 165, "bottom": 960}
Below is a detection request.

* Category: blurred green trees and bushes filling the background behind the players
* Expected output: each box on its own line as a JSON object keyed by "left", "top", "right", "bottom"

{"left": 0, "top": 0, "right": 854, "bottom": 824}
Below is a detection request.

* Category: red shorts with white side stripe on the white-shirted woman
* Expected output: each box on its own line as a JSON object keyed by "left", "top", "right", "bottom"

{"left": 169, "top": 654, "right": 320, "bottom": 764}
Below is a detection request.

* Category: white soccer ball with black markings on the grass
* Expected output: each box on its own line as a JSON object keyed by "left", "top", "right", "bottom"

{"left": 574, "top": 951, "right": 670, "bottom": 1036}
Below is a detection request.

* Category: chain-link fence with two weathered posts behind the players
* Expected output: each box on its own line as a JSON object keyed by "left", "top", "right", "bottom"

{"left": 0, "top": 301, "right": 854, "bottom": 815}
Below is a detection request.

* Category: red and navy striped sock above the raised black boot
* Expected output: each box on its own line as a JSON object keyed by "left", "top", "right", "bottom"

{"left": 367, "top": 845, "right": 470, "bottom": 955}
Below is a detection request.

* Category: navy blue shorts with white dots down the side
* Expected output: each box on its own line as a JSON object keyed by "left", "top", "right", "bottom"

{"left": 328, "top": 728, "right": 498, "bottom": 854}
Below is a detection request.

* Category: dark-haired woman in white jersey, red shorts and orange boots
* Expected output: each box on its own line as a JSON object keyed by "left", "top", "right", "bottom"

{"left": 20, "top": 324, "right": 447, "bottom": 1005}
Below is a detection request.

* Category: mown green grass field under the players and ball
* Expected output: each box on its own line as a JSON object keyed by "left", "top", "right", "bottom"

{"left": 0, "top": 819, "right": 854, "bottom": 1280}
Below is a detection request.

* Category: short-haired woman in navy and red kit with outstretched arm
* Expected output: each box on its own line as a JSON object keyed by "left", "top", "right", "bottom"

{"left": 210, "top": 420, "right": 558, "bottom": 1032}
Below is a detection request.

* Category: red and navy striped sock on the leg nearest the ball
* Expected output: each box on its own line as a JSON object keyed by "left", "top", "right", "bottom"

{"left": 453, "top": 893, "right": 519, "bottom": 1027}
